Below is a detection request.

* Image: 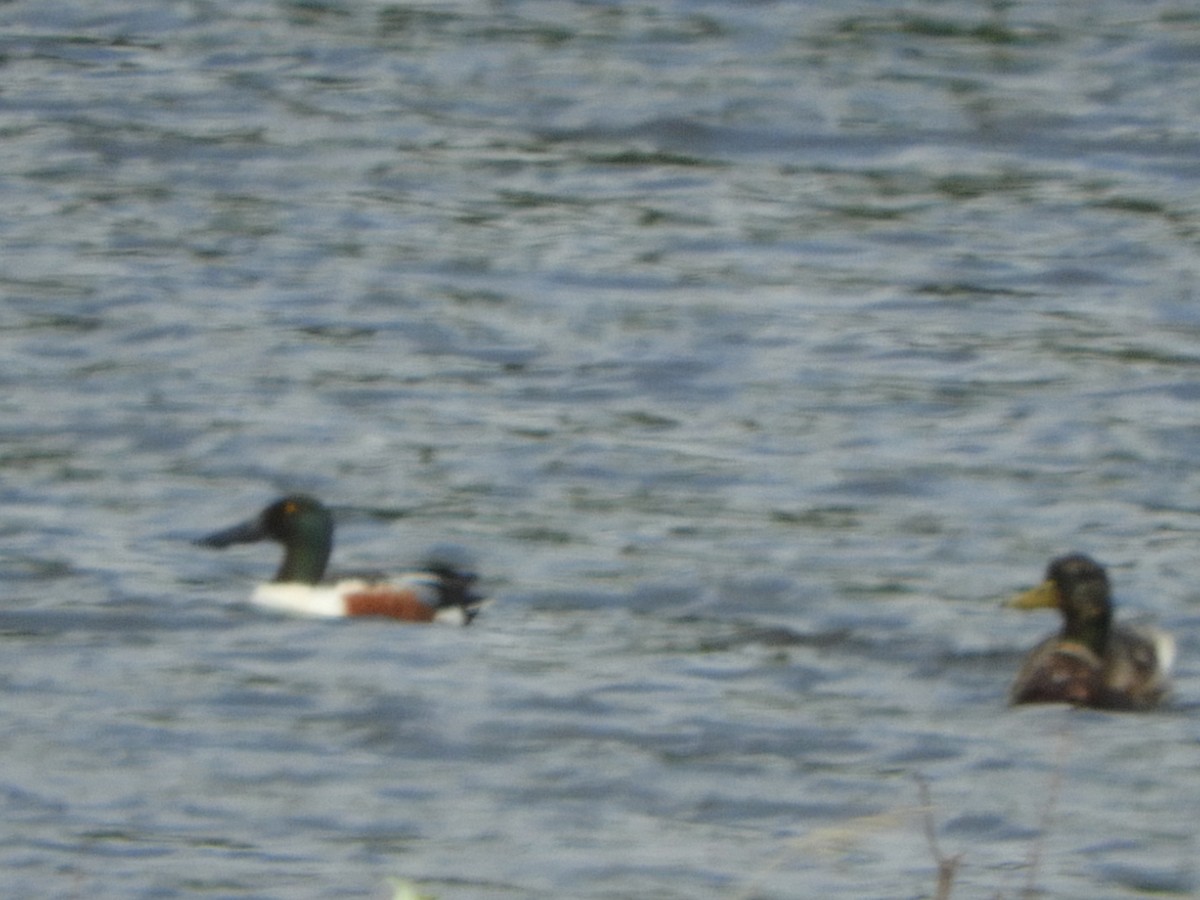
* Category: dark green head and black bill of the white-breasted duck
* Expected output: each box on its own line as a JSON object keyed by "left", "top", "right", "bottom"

{"left": 197, "top": 493, "right": 334, "bottom": 584}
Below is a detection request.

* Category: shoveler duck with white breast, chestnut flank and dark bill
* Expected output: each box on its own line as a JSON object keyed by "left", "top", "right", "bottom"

{"left": 196, "top": 494, "right": 484, "bottom": 625}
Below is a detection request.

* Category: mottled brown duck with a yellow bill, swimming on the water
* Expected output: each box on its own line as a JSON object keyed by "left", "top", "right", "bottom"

{"left": 1008, "top": 553, "right": 1175, "bottom": 709}
